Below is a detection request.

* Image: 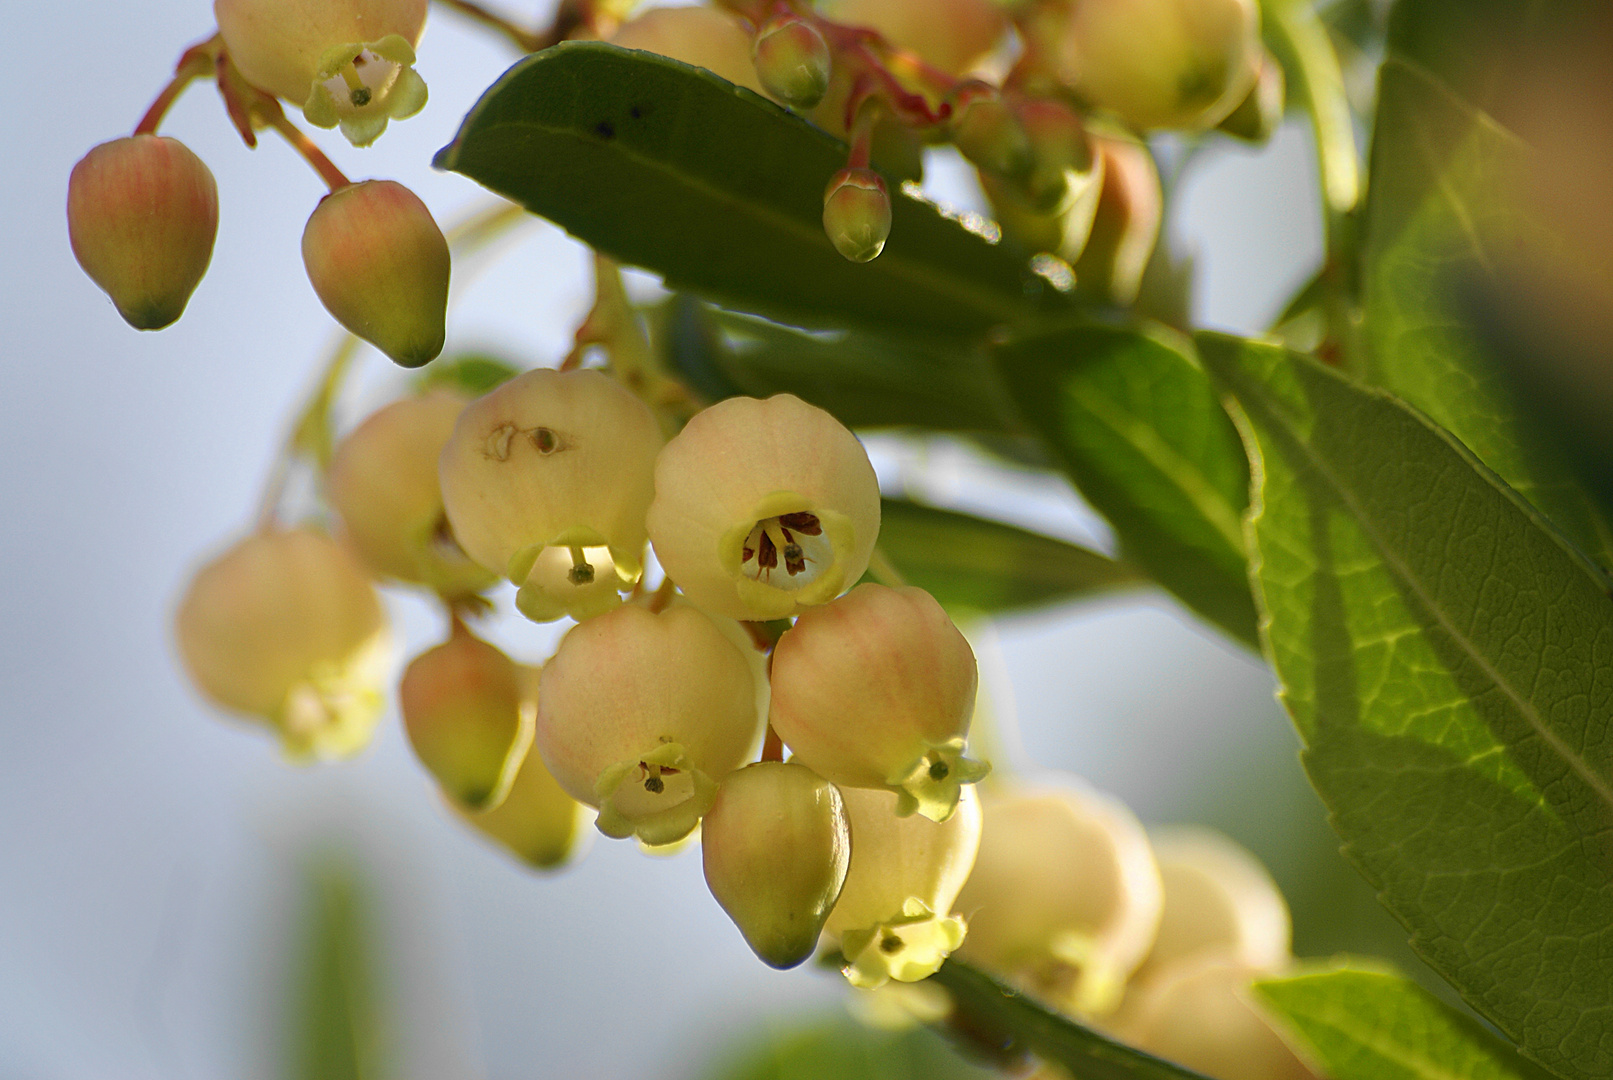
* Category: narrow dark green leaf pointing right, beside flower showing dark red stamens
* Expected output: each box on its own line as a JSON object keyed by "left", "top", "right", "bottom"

{"left": 879, "top": 498, "right": 1150, "bottom": 613}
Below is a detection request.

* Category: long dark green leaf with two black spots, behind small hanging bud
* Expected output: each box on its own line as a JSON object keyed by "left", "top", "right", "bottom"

{"left": 437, "top": 42, "right": 1071, "bottom": 335}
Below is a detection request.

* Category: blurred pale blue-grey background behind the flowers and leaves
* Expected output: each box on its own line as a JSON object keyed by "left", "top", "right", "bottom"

{"left": 0, "top": 0, "right": 1416, "bottom": 1080}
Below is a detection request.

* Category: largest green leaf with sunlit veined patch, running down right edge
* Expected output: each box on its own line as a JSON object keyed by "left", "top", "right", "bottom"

{"left": 1198, "top": 334, "right": 1613, "bottom": 1080}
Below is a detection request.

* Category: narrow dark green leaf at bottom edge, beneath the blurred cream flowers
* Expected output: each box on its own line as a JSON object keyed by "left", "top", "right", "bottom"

{"left": 931, "top": 957, "right": 1205, "bottom": 1080}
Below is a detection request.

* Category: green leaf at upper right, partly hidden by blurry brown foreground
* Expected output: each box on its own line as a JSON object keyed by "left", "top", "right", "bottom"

{"left": 1365, "top": 61, "right": 1613, "bottom": 580}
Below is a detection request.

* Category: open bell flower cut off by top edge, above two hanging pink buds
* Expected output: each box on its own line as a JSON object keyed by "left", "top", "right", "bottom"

{"left": 213, "top": 0, "right": 426, "bottom": 147}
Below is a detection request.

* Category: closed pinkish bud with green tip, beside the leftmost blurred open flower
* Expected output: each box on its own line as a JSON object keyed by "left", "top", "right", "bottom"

{"left": 398, "top": 619, "right": 537, "bottom": 809}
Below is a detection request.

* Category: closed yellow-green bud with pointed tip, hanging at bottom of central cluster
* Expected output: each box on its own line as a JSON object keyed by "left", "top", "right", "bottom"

{"left": 700, "top": 761, "right": 852, "bottom": 967}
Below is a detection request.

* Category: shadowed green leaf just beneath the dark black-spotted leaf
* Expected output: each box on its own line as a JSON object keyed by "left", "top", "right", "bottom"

{"left": 661, "top": 300, "right": 1011, "bottom": 432}
